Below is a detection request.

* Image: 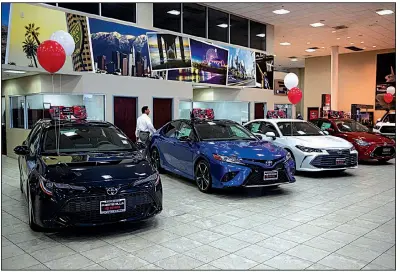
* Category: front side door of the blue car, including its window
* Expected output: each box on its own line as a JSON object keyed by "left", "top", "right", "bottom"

{"left": 174, "top": 122, "right": 197, "bottom": 177}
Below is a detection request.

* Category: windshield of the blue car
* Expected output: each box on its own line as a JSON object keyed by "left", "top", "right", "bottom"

{"left": 195, "top": 122, "right": 257, "bottom": 141}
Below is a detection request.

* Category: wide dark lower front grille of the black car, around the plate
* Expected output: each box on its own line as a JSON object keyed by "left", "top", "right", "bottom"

{"left": 60, "top": 193, "right": 155, "bottom": 224}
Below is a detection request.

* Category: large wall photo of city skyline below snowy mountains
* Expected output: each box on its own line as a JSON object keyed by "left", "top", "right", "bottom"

{"left": 89, "top": 18, "right": 151, "bottom": 77}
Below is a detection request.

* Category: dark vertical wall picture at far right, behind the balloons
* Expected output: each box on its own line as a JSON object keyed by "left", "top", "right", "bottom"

{"left": 375, "top": 53, "right": 396, "bottom": 110}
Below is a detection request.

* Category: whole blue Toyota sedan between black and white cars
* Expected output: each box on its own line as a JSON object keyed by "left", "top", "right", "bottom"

{"left": 150, "top": 119, "right": 295, "bottom": 192}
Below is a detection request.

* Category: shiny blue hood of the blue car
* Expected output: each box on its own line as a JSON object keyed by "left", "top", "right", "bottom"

{"left": 202, "top": 141, "right": 286, "bottom": 160}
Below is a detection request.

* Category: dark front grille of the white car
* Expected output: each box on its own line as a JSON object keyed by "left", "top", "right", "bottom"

{"left": 311, "top": 149, "right": 357, "bottom": 169}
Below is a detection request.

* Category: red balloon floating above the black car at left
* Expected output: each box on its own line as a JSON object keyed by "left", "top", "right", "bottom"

{"left": 37, "top": 40, "right": 66, "bottom": 74}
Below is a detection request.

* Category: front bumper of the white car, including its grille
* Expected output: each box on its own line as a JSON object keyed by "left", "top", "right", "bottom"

{"left": 296, "top": 149, "right": 358, "bottom": 172}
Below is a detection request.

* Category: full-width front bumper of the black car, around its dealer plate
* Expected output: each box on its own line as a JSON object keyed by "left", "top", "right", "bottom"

{"left": 35, "top": 181, "right": 162, "bottom": 229}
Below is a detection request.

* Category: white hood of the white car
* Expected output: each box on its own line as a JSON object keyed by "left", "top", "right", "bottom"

{"left": 287, "top": 135, "right": 352, "bottom": 149}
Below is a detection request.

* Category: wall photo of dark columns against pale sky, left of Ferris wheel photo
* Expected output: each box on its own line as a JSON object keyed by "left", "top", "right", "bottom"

{"left": 147, "top": 33, "right": 192, "bottom": 71}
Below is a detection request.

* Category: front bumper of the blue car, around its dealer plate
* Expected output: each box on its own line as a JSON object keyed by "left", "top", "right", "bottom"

{"left": 211, "top": 159, "right": 296, "bottom": 188}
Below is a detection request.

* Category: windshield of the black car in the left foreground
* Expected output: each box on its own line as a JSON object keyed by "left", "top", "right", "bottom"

{"left": 43, "top": 125, "right": 136, "bottom": 153}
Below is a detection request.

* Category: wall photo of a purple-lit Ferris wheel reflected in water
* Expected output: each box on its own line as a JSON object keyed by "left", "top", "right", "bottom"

{"left": 168, "top": 39, "right": 229, "bottom": 85}
